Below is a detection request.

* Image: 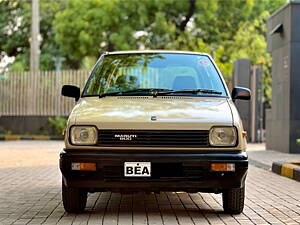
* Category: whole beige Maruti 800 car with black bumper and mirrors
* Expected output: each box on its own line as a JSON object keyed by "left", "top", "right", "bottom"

{"left": 60, "top": 51, "right": 250, "bottom": 213}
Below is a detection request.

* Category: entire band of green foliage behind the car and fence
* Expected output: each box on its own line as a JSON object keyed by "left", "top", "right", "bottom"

{"left": 0, "top": 0, "right": 286, "bottom": 101}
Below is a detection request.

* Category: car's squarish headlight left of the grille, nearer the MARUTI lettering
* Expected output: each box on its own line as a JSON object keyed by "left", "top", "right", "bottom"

{"left": 70, "top": 126, "right": 97, "bottom": 145}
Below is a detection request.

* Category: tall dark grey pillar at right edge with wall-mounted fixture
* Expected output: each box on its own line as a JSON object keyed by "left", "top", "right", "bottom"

{"left": 266, "top": 2, "right": 300, "bottom": 153}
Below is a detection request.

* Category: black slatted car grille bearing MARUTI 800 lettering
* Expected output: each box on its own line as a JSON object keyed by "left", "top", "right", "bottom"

{"left": 98, "top": 130, "right": 209, "bottom": 147}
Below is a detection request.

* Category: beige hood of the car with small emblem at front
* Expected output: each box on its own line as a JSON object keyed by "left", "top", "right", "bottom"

{"left": 71, "top": 96, "right": 233, "bottom": 129}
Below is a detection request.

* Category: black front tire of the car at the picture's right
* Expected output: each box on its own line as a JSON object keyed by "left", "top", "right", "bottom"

{"left": 222, "top": 187, "right": 245, "bottom": 214}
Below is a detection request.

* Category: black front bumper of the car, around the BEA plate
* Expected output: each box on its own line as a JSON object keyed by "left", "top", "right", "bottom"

{"left": 60, "top": 150, "right": 248, "bottom": 193}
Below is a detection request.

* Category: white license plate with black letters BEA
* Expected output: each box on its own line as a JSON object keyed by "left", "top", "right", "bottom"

{"left": 124, "top": 162, "right": 151, "bottom": 177}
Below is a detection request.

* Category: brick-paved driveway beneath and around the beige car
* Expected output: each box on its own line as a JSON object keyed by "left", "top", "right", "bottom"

{"left": 0, "top": 141, "right": 300, "bottom": 225}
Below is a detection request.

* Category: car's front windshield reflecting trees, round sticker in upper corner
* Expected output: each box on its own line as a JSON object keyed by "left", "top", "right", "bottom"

{"left": 82, "top": 53, "right": 227, "bottom": 97}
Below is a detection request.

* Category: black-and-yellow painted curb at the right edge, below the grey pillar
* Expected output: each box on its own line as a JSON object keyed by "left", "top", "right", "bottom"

{"left": 272, "top": 161, "right": 300, "bottom": 181}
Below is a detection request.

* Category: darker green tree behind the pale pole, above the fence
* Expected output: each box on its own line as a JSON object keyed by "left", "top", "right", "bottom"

{"left": 0, "top": 0, "right": 70, "bottom": 71}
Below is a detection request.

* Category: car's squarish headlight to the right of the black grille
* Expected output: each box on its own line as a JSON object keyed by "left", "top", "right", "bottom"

{"left": 209, "top": 127, "right": 237, "bottom": 146}
